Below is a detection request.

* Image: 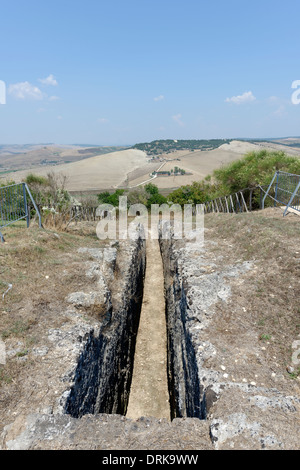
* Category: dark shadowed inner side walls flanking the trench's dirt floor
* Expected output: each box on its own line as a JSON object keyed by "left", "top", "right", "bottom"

{"left": 65, "top": 237, "right": 205, "bottom": 420}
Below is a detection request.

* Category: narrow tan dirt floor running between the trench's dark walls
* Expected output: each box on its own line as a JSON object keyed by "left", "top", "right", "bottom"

{"left": 127, "top": 239, "right": 170, "bottom": 420}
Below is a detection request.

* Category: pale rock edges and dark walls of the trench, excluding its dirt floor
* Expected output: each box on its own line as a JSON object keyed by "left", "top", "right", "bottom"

{"left": 1, "top": 224, "right": 300, "bottom": 450}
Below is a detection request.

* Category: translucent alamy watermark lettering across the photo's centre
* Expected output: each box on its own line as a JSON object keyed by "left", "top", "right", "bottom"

{"left": 96, "top": 196, "right": 204, "bottom": 244}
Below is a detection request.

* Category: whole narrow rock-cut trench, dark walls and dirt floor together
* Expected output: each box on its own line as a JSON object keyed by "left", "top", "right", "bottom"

{"left": 65, "top": 229, "right": 202, "bottom": 420}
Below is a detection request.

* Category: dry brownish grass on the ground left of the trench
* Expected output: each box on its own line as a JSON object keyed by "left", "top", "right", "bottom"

{"left": 0, "top": 222, "right": 105, "bottom": 385}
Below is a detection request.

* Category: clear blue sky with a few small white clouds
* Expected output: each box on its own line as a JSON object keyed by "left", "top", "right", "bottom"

{"left": 0, "top": 0, "right": 300, "bottom": 145}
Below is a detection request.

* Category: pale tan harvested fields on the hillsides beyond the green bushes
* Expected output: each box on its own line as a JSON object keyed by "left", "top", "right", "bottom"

{"left": 0, "top": 140, "right": 300, "bottom": 193}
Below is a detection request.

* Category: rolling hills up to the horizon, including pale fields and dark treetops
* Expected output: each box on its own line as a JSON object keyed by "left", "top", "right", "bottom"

{"left": 0, "top": 138, "right": 300, "bottom": 193}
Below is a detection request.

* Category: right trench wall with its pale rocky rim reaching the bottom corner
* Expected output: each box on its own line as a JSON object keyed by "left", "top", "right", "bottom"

{"left": 160, "top": 226, "right": 300, "bottom": 450}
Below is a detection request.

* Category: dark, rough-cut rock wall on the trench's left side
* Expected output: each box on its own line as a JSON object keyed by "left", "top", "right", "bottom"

{"left": 65, "top": 233, "right": 146, "bottom": 417}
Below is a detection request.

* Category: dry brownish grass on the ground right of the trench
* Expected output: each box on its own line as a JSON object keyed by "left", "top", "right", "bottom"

{"left": 205, "top": 208, "right": 300, "bottom": 378}
